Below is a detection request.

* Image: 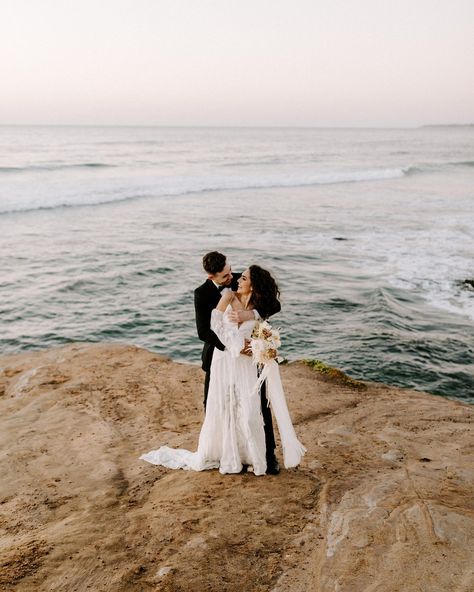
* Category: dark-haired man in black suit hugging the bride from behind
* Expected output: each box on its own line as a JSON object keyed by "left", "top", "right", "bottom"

{"left": 194, "top": 251, "right": 280, "bottom": 475}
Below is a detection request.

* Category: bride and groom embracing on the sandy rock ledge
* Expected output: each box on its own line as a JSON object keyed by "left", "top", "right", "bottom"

{"left": 140, "top": 251, "right": 305, "bottom": 475}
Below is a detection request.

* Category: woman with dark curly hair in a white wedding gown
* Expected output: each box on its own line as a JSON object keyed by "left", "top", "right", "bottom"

{"left": 140, "top": 265, "right": 306, "bottom": 475}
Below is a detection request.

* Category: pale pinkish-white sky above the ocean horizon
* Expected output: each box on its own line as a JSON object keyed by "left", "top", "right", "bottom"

{"left": 0, "top": 0, "right": 474, "bottom": 127}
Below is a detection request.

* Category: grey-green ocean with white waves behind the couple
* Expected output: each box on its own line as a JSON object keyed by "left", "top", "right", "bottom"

{"left": 0, "top": 126, "right": 474, "bottom": 402}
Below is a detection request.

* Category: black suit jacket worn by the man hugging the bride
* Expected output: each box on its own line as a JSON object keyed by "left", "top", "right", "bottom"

{"left": 194, "top": 273, "right": 242, "bottom": 372}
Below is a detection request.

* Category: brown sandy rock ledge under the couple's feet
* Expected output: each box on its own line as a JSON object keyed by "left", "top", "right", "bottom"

{"left": 0, "top": 344, "right": 474, "bottom": 592}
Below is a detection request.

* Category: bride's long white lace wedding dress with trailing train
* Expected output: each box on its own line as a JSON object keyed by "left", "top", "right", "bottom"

{"left": 140, "top": 306, "right": 305, "bottom": 475}
